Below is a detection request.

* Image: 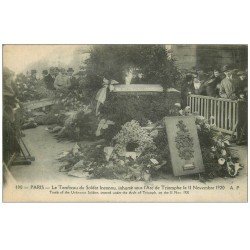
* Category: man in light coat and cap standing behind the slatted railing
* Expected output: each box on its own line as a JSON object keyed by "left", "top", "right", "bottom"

{"left": 219, "top": 65, "right": 237, "bottom": 100}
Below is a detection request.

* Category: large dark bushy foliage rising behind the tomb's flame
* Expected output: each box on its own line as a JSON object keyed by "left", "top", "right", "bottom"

{"left": 86, "top": 45, "right": 180, "bottom": 90}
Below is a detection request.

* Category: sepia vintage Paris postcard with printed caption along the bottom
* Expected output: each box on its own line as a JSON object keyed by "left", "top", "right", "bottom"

{"left": 2, "top": 44, "right": 248, "bottom": 202}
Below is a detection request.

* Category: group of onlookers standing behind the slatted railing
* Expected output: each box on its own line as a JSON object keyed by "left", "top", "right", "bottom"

{"left": 181, "top": 65, "right": 248, "bottom": 107}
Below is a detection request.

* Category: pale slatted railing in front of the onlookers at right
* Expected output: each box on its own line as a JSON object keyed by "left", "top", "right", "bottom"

{"left": 187, "top": 94, "right": 247, "bottom": 134}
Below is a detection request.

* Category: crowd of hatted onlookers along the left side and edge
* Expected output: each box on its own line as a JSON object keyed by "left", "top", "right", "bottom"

{"left": 3, "top": 67, "right": 87, "bottom": 164}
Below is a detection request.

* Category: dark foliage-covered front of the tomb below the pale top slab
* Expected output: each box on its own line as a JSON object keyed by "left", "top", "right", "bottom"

{"left": 100, "top": 93, "right": 179, "bottom": 137}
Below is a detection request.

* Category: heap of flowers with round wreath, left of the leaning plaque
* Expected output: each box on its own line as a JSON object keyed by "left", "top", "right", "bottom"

{"left": 57, "top": 120, "right": 167, "bottom": 181}
